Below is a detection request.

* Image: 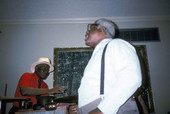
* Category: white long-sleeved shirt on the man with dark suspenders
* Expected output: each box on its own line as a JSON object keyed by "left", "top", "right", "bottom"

{"left": 78, "top": 38, "right": 142, "bottom": 114}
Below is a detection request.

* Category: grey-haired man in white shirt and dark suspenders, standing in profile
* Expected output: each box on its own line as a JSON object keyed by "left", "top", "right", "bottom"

{"left": 69, "top": 19, "right": 142, "bottom": 114}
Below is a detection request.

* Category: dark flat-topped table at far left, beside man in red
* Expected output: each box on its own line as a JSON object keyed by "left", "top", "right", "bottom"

{"left": 0, "top": 96, "right": 30, "bottom": 114}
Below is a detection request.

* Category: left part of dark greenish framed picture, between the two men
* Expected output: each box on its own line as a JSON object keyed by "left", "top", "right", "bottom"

{"left": 54, "top": 47, "right": 93, "bottom": 98}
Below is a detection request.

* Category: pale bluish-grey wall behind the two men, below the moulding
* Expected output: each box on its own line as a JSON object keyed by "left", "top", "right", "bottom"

{"left": 0, "top": 19, "right": 170, "bottom": 114}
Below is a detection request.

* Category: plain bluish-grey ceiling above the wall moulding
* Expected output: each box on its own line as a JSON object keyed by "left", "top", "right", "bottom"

{"left": 0, "top": 0, "right": 170, "bottom": 20}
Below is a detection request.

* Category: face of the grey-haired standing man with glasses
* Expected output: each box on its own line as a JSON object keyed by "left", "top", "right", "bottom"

{"left": 85, "top": 24, "right": 102, "bottom": 47}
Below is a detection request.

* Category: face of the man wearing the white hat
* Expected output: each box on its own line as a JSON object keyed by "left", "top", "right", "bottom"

{"left": 35, "top": 64, "right": 50, "bottom": 80}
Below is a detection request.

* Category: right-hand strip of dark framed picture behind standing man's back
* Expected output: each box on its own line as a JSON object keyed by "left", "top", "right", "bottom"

{"left": 134, "top": 45, "right": 155, "bottom": 113}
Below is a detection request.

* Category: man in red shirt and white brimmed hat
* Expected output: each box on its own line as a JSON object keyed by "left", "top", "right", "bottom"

{"left": 9, "top": 58, "right": 64, "bottom": 114}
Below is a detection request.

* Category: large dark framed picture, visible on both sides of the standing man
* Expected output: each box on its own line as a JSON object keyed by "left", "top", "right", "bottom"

{"left": 53, "top": 45, "right": 155, "bottom": 113}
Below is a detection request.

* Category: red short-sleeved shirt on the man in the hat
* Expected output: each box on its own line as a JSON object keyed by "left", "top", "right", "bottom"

{"left": 14, "top": 73, "right": 48, "bottom": 107}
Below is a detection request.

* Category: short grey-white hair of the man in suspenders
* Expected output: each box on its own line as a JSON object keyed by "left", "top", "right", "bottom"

{"left": 96, "top": 18, "right": 115, "bottom": 38}
